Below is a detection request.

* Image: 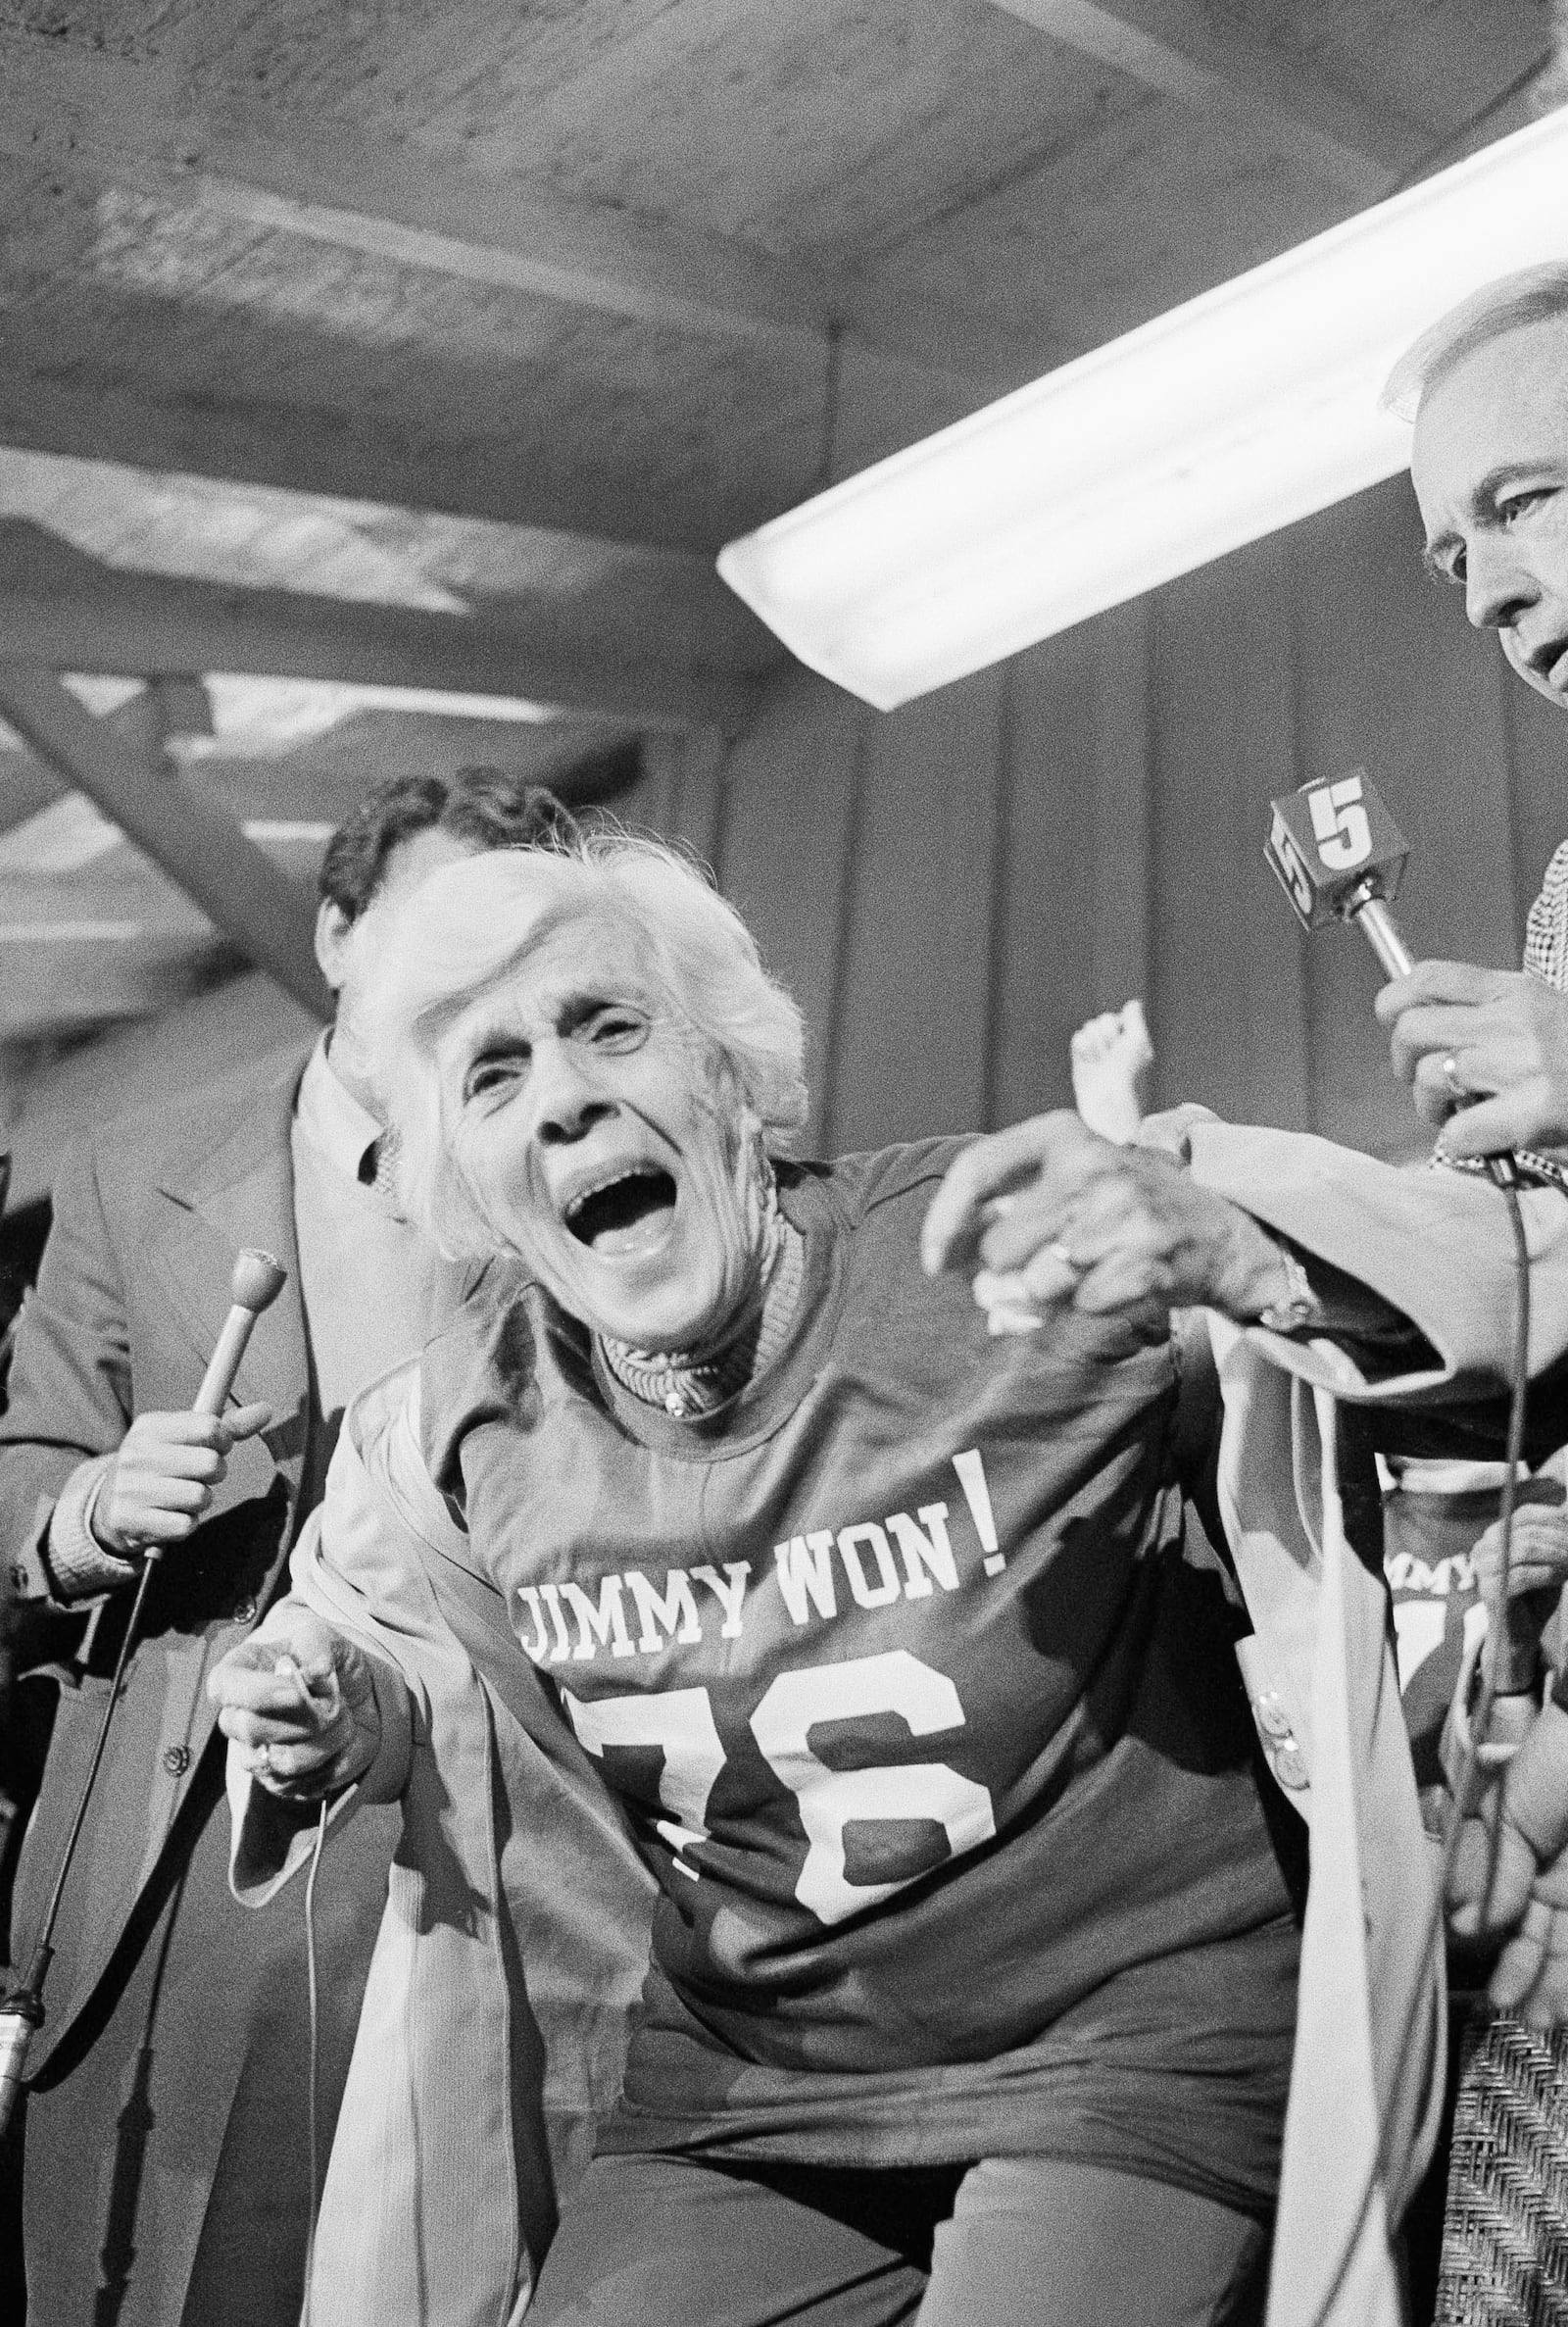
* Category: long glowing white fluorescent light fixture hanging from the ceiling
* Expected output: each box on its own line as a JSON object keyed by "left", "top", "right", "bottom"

{"left": 719, "top": 112, "right": 1568, "bottom": 710}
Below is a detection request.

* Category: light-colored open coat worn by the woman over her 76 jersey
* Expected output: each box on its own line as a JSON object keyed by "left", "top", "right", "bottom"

{"left": 230, "top": 1124, "right": 1568, "bottom": 2327}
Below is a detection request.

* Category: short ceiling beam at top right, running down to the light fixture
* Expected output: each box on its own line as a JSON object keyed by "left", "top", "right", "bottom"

{"left": 989, "top": 0, "right": 1431, "bottom": 203}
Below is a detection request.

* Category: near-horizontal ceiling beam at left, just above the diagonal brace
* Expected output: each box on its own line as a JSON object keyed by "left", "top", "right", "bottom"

{"left": 0, "top": 572, "right": 759, "bottom": 733}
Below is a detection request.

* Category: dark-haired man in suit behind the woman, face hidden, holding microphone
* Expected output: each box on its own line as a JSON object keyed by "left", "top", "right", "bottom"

{"left": 0, "top": 767, "right": 570, "bottom": 2327}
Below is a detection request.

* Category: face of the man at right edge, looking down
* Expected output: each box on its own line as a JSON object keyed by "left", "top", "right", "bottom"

{"left": 1410, "top": 317, "right": 1568, "bottom": 705}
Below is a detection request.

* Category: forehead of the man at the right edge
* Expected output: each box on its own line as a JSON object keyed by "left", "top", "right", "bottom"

{"left": 1410, "top": 317, "right": 1568, "bottom": 517}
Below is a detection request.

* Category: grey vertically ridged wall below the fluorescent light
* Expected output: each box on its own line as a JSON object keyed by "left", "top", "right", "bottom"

{"left": 626, "top": 479, "right": 1568, "bottom": 1155}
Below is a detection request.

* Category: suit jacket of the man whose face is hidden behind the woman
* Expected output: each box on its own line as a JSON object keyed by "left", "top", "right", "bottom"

{"left": 0, "top": 1047, "right": 461, "bottom": 2080}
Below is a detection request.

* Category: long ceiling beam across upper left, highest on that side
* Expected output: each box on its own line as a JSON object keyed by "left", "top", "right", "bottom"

{"left": 0, "top": 39, "right": 1040, "bottom": 388}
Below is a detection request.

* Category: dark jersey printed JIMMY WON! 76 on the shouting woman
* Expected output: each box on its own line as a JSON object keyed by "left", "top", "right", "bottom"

{"left": 421, "top": 1143, "right": 1294, "bottom": 2178}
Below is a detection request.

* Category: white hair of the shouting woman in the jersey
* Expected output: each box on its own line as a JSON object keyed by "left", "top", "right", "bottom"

{"left": 353, "top": 831, "right": 808, "bottom": 1259}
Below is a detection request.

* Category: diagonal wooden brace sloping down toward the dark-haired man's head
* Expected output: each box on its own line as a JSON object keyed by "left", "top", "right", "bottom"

{"left": 0, "top": 661, "right": 332, "bottom": 1019}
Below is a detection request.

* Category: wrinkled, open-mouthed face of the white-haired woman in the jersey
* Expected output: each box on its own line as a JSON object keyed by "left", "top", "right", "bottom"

{"left": 435, "top": 913, "right": 765, "bottom": 1355}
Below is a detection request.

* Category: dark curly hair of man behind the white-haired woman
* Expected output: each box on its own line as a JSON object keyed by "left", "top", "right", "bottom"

{"left": 321, "top": 767, "right": 577, "bottom": 921}
